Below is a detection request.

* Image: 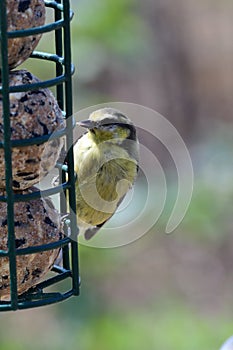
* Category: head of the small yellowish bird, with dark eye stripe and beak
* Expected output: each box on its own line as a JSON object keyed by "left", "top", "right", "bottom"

{"left": 77, "top": 108, "right": 137, "bottom": 143}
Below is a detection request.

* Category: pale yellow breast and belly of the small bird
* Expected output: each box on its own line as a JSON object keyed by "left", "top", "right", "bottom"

{"left": 74, "top": 133, "right": 137, "bottom": 225}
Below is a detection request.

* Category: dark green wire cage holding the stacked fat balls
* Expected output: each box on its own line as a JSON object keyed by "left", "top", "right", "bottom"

{"left": 0, "top": 0, "right": 80, "bottom": 311}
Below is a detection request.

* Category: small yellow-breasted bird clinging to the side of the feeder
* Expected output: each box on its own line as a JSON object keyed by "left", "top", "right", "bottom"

{"left": 74, "top": 108, "right": 139, "bottom": 239}
